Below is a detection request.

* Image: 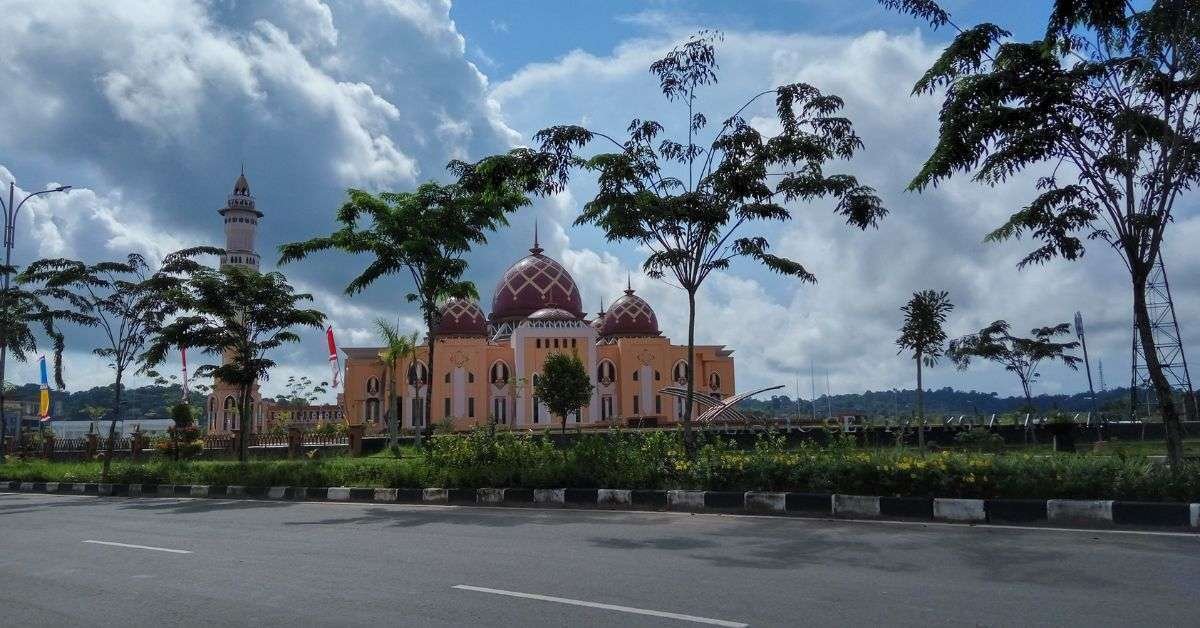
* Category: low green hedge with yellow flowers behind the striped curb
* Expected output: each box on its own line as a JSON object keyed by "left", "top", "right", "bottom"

{"left": 0, "top": 427, "right": 1200, "bottom": 501}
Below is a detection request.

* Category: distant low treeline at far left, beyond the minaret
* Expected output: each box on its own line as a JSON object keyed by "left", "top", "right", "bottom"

{"left": 7, "top": 384, "right": 204, "bottom": 420}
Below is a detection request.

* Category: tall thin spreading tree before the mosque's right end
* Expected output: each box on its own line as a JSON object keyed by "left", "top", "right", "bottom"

{"left": 501, "top": 31, "right": 887, "bottom": 451}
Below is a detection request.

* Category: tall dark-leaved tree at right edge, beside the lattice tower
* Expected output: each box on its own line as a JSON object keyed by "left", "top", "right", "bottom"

{"left": 882, "top": 0, "right": 1200, "bottom": 465}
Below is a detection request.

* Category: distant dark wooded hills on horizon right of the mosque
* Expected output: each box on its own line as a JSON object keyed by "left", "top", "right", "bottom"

{"left": 738, "top": 387, "right": 1129, "bottom": 418}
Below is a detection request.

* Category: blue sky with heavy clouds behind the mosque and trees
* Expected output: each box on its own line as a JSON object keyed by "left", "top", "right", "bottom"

{"left": 0, "top": 0, "right": 1200, "bottom": 403}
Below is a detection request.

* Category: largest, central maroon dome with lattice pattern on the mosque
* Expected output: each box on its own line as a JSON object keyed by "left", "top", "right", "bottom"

{"left": 492, "top": 244, "right": 583, "bottom": 321}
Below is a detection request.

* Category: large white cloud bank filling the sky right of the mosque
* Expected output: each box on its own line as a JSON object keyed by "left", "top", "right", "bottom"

{"left": 492, "top": 31, "right": 1200, "bottom": 394}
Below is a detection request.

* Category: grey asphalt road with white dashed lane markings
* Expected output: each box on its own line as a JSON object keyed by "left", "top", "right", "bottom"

{"left": 0, "top": 494, "right": 1200, "bottom": 627}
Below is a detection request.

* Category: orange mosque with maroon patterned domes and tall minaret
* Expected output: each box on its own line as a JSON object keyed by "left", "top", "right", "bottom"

{"left": 206, "top": 173, "right": 734, "bottom": 433}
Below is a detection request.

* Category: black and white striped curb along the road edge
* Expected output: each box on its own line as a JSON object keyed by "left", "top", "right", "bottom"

{"left": 0, "top": 480, "right": 1200, "bottom": 530}
